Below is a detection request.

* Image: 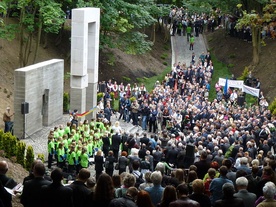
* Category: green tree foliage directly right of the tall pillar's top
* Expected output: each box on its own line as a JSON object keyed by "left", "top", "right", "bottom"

{"left": 77, "top": 0, "right": 156, "bottom": 54}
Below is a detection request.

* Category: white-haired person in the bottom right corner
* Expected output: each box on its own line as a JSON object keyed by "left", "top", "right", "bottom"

{"left": 257, "top": 182, "right": 276, "bottom": 207}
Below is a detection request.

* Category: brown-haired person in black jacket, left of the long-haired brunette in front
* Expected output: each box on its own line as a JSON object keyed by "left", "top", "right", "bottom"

{"left": 69, "top": 168, "right": 91, "bottom": 207}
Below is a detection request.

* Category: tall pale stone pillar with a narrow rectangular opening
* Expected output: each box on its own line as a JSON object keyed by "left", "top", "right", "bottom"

{"left": 70, "top": 8, "right": 100, "bottom": 119}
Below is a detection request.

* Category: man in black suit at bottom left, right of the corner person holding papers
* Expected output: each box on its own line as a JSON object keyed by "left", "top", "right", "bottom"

{"left": 20, "top": 162, "right": 51, "bottom": 207}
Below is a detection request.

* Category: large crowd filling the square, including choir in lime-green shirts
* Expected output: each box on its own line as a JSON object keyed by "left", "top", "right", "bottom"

{"left": 0, "top": 6, "right": 276, "bottom": 207}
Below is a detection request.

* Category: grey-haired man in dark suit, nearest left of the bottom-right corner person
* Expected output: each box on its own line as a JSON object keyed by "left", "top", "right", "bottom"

{"left": 234, "top": 177, "right": 257, "bottom": 207}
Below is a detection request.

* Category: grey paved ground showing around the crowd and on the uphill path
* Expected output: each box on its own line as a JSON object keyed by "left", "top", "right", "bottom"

{"left": 22, "top": 31, "right": 206, "bottom": 175}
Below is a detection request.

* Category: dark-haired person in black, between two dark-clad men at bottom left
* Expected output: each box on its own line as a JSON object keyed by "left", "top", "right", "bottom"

{"left": 42, "top": 168, "right": 73, "bottom": 207}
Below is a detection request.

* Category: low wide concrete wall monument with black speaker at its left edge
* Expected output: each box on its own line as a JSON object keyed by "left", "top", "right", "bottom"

{"left": 14, "top": 59, "right": 64, "bottom": 138}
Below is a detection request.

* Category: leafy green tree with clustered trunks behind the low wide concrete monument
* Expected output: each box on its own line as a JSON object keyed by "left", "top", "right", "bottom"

{"left": 0, "top": 0, "right": 65, "bottom": 67}
